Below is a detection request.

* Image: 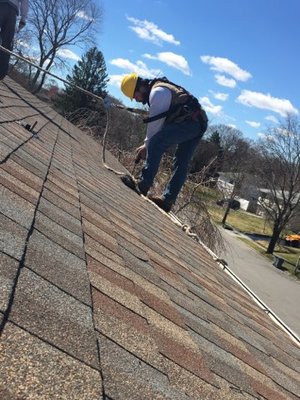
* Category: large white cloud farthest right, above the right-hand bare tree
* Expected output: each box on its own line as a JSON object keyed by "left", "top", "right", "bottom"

{"left": 236, "top": 90, "right": 299, "bottom": 117}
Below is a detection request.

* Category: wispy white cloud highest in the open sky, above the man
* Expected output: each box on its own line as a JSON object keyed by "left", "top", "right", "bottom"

{"left": 127, "top": 17, "right": 180, "bottom": 46}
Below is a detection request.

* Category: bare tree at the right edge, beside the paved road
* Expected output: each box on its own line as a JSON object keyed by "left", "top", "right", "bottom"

{"left": 255, "top": 116, "right": 300, "bottom": 254}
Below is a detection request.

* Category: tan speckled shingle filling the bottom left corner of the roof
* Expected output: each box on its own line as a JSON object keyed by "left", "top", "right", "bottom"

{"left": 0, "top": 324, "right": 103, "bottom": 400}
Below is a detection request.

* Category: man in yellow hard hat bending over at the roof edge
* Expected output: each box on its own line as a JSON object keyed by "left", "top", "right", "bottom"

{"left": 121, "top": 74, "right": 207, "bottom": 212}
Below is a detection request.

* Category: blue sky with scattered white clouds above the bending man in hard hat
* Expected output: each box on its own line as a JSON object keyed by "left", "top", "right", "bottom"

{"left": 66, "top": 0, "right": 300, "bottom": 140}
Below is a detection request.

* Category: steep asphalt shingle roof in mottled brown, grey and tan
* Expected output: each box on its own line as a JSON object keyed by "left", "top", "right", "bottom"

{"left": 0, "top": 78, "right": 300, "bottom": 400}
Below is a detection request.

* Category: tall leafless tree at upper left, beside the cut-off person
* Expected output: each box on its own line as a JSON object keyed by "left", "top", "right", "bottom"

{"left": 28, "top": 0, "right": 101, "bottom": 93}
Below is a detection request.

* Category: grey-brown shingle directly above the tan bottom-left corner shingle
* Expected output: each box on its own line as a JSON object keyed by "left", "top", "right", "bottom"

{"left": 9, "top": 268, "right": 98, "bottom": 368}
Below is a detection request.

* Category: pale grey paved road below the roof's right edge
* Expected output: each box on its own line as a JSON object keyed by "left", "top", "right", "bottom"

{"left": 218, "top": 228, "right": 300, "bottom": 338}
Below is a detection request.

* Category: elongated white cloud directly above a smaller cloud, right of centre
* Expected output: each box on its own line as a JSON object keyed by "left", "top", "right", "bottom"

{"left": 200, "top": 56, "right": 252, "bottom": 82}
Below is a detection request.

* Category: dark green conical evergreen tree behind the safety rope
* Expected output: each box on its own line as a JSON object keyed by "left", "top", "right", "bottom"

{"left": 55, "top": 47, "right": 108, "bottom": 114}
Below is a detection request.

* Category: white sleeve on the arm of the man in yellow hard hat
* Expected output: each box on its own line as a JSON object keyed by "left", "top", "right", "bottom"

{"left": 144, "top": 86, "right": 172, "bottom": 148}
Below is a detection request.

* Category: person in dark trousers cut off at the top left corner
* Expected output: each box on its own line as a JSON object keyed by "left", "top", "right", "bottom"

{"left": 0, "top": 0, "right": 28, "bottom": 80}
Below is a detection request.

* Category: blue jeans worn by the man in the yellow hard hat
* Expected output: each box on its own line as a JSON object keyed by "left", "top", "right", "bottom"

{"left": 139, "top": 121, "right": 203, "bottom": 203}
